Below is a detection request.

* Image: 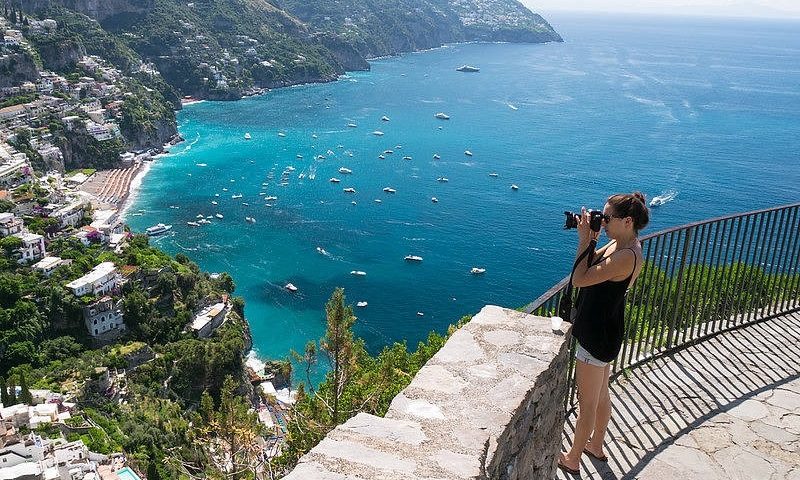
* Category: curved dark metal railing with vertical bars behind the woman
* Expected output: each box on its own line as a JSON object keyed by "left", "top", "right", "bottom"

{"left": 525, "top": 203, "right": 800, "bottom": 408}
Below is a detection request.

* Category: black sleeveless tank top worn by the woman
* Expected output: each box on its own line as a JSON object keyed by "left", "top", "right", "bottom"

{"left": 572, "top": 248, "right": 636, "bottom": 362}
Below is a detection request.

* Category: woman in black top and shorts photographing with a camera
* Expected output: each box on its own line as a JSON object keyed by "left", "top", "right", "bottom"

{"left": 558, "top": 192, "right": 650, "bottom": 475}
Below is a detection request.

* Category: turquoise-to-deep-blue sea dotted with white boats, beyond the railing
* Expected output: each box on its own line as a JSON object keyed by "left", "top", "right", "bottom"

{"left": 126, "top": 15, "right": 800, "bottom": 376}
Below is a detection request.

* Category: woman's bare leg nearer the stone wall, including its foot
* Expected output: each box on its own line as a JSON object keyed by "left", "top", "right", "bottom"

{"left": 561, "top": 360, "right": 607, "bottom": 470}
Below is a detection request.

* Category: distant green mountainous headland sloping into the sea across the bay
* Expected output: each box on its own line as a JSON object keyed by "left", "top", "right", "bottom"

{"left": 30, "top": 0, "right": 562, "bottom": 100}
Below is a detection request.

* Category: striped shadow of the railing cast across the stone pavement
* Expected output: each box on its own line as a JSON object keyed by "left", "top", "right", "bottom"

{"left": 558, "top": 311, "right": 800, "bottom": 480}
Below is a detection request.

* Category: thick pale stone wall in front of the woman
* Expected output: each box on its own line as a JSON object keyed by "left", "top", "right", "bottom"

{"left": 284, "top": 306, "right": 568, "bottom": 480}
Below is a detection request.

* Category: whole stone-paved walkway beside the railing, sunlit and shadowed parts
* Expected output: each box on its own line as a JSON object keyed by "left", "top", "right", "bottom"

{"left": 557, "top": 313, "right": 800, "bottom": 480}
